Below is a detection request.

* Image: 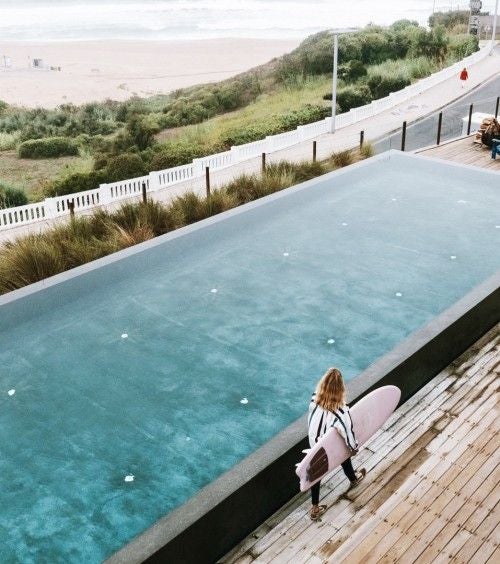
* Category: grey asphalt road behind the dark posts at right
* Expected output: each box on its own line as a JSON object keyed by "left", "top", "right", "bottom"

{"left": 373, "top": 72, "right": 500, "bottom": 153}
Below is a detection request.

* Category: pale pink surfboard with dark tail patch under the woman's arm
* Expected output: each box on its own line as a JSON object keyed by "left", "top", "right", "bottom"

{"left": 295, "top": 386, "right": 401, "bottom": 492}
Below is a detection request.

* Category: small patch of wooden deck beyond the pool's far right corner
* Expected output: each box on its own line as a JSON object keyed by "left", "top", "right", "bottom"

{"left": 415, "top": 135, "right": 500, "bottom": 172}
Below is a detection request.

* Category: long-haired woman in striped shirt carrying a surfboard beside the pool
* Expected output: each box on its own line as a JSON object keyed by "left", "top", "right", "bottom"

{"left": 308, "top": 368, "right": 366, "bottom": 521}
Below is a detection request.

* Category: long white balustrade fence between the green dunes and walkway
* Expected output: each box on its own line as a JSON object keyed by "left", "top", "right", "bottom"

{"left": 0, "top": 45, "right": 491, "bottom": 231}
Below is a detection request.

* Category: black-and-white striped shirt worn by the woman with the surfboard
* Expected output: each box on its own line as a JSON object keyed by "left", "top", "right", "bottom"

{"left": 308, "top": 393, "right": 358, "bottom": 449}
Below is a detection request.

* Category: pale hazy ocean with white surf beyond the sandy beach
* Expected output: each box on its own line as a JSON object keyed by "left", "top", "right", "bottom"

{"left": 0, "top": 0, "right": 484, "bottom": 41}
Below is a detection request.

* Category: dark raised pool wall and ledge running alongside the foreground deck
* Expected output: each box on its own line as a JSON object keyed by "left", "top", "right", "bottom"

{"left": 106, "top": 271, "right": 500, "bottom": 564}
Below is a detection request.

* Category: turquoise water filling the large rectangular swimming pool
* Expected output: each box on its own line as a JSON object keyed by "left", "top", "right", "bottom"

{"left": 0, "top": 154, "right": 500, "bottom": 563}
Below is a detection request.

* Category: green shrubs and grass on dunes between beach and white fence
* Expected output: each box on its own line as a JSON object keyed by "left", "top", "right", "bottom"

{"left": 0, "top": 12, "right": 478, "bottom": 207}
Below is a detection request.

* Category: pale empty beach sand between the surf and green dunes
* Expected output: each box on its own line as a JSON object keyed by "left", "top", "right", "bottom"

{"left": 0, "top": 39, "right": 299, "bottom": 108}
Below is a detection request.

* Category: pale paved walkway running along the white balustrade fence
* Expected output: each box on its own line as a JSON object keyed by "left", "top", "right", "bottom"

{"left": 0, "top": 47, "right": 500, "bottom": 242}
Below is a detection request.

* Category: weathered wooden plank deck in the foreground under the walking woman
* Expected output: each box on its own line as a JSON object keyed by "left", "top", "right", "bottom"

{"left": 220, "top": 326, "right": 500, "bottom": 564}
